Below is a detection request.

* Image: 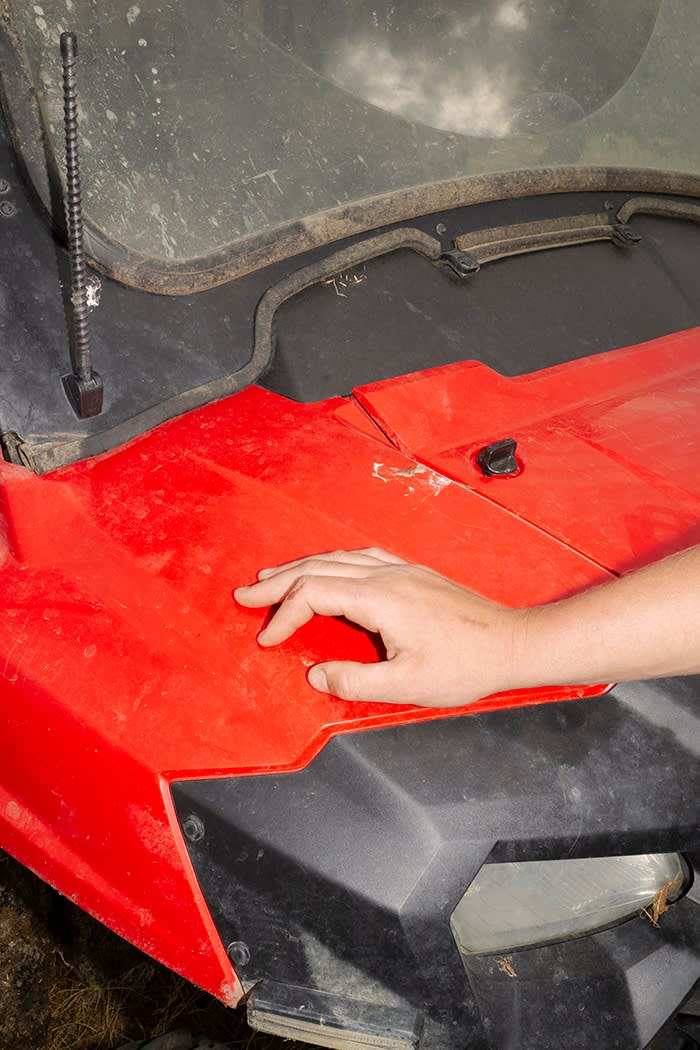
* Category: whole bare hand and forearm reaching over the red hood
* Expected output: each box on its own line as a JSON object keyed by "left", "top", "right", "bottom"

{"left": 234, "top": 546, "right": 700, "bottom": 708}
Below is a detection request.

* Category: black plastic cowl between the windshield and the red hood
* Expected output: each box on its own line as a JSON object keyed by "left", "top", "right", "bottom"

{"left": 0, "top": 103, "right": 700, "bottom": 473}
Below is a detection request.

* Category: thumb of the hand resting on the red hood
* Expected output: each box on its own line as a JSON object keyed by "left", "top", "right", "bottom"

{"left": 307, "top": 656, "right": 416, "bottom": 704}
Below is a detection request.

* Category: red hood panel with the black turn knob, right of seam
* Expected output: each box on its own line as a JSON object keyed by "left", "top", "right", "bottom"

{"left": 357, "top": 329, "right": 700, "bottom": 571}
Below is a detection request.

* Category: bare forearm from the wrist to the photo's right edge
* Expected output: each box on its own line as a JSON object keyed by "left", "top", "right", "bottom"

{"left": 513, "top": 547, "right": 700, "bottom": 687}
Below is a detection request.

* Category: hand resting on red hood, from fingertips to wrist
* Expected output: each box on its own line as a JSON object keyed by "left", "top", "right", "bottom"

{"left": 234, "top": 548, "right": 527, "bottom": 708}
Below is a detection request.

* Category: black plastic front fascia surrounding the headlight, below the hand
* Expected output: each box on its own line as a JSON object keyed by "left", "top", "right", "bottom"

{"left": 173, "top": 677, "right": 700, "bottom": 1050}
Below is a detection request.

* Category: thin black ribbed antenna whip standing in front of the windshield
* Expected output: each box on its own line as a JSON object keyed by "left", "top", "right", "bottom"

{"left": 61, "top": 33, "right": 103, "bottom": 419}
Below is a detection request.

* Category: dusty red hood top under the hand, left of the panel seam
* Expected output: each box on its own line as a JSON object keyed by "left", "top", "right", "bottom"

{"left": 0, "top": 389, "right": 604, "bottom": 785}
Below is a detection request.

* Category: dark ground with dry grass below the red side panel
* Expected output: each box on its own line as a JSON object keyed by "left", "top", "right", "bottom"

{"left": 0, "top": 853, "right": 295, "bottom": 1050}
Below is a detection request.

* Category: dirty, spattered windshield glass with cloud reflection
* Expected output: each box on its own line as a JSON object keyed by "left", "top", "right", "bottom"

{"left": 14, "top": 0, "right": 700, "bottom": 261}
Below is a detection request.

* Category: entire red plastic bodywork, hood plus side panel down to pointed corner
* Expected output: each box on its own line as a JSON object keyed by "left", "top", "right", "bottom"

{"left": 0, "top": 332, "right": 700, "bottom": 1002}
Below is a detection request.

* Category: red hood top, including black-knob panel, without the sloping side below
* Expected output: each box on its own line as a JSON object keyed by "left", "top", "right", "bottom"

{"left": 0, "top": 330, "right": 700, "bottom": 778}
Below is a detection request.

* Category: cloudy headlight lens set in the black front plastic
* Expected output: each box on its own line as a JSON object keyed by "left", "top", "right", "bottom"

{"left": 451, "top": 854, "right": 687, "bottom": 953}
